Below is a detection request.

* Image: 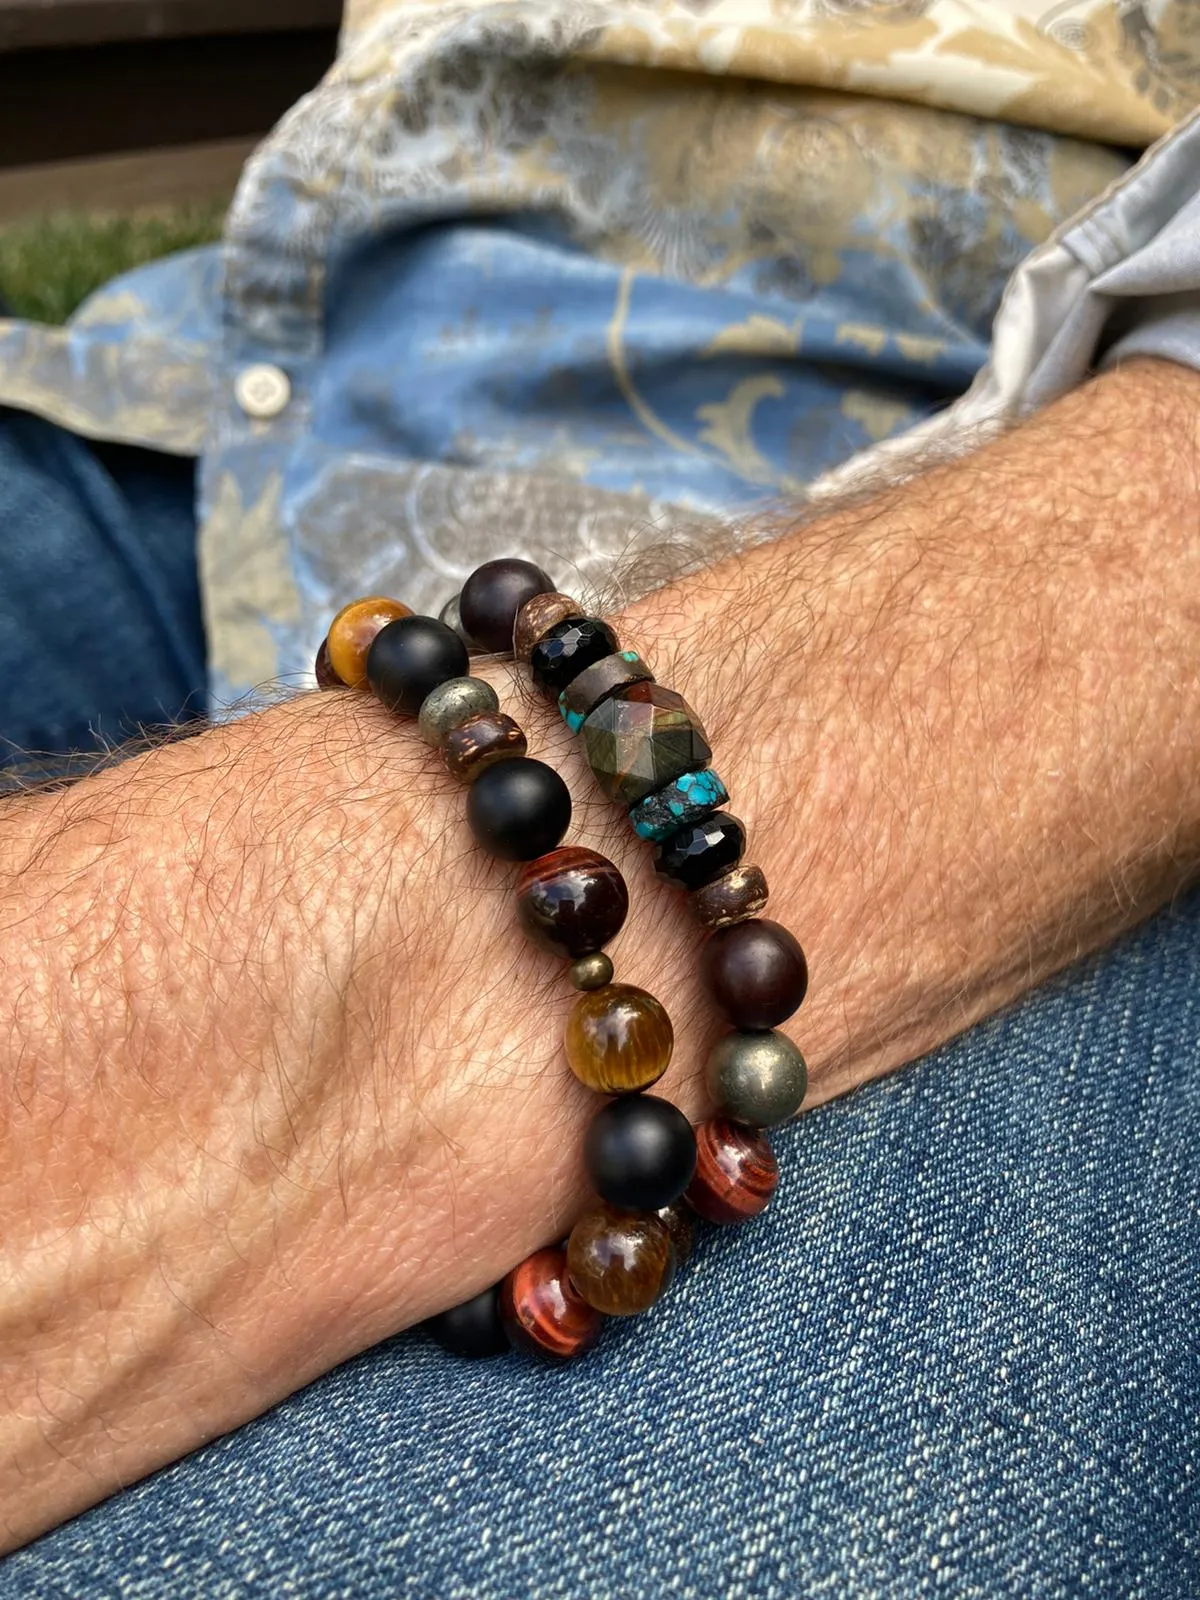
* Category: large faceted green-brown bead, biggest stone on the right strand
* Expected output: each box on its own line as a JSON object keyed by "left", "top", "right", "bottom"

{"left": 582, "top": 683, "right": 712, "bottom": 806}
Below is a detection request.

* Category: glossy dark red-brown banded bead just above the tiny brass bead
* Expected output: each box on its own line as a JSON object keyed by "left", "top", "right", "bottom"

{"left": 517, "top": 845, "right": 629, "bottom": 962}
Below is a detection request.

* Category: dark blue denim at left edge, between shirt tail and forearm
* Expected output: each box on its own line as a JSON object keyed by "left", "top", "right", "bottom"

{"left": 0, "top": 410, "right": 205, "bottom": 766}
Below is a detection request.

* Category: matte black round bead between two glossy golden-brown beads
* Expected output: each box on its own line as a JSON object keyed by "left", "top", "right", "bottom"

{"left": 584, "top": 1094, "right": 696, "bottom": 1211}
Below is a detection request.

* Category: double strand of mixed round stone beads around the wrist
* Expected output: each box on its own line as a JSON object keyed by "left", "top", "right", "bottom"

{"left": 317, "top": 560, "right": 808, "bottom": 1358}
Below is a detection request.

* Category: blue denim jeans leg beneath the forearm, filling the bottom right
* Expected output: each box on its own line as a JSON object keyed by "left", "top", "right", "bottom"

{"left": 0, "top": 899, "right": 1200, "bottom": 1600}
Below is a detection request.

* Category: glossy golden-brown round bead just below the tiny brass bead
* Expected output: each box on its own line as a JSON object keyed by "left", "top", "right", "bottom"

{"left": 565, "top": 984, "right": 675, "bottom": 1094}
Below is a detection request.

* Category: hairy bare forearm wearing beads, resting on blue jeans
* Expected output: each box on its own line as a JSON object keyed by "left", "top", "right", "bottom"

{"left": 0, "top": 353, "right": 1200, "bottom": 1539}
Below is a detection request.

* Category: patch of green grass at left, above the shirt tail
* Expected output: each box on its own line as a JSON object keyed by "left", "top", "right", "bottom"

{"left": 0, "top": 202, "right": 226, "bottom": 322}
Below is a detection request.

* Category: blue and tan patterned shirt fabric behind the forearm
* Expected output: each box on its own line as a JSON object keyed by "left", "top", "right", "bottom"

{"left": 0, "top": 0, "right": 1200, "bottom": 702}
